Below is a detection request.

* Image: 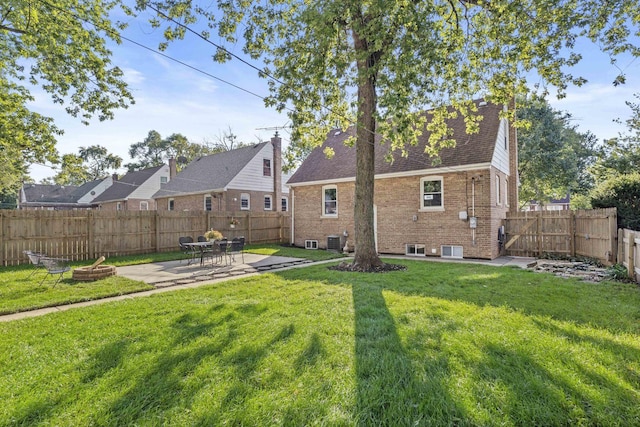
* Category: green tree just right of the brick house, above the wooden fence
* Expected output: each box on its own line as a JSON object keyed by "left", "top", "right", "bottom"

{"left": 518, "top": 96, "right": 597, "bottom": 210}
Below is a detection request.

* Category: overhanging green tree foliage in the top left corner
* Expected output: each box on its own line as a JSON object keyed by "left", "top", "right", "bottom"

{"left": 0, "top": 0, "right": 133, "bottom": 196}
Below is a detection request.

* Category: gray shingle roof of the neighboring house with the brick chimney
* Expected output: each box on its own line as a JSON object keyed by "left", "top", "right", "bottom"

{"left": 153, "top": 142, "right": 269, "bottom": 199}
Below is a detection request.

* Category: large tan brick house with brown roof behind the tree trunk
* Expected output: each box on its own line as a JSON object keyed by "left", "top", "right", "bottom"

{"left": 287, "top": 101, "right": 518, "bottom": 259}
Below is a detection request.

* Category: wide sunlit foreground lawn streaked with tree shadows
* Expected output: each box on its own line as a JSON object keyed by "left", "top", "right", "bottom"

{"left": 0, "top": 261, "right": 640, "bottom": 426}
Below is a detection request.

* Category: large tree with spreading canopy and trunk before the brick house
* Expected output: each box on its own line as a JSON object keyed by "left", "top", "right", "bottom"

{"left": 144, "top": 0, "right": 640, "bottom": 270}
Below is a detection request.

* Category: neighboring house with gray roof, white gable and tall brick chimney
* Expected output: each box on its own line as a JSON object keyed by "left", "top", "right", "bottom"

{"left": 153, "top": 135, "right": 290, "bottom": 212}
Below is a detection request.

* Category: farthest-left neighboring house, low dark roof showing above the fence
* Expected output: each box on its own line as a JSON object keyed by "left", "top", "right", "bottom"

{"left": 17, "top": 177, "right": 113, "bottom": 210}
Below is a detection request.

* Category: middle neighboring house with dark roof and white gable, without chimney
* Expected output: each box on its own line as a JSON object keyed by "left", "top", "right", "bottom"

{"left": 93, "top": 165, "right": 175, "bottom": 211}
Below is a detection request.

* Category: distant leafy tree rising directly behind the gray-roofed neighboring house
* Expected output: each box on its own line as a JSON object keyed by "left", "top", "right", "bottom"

{"left": 125, "top": 130, "right": 215, "bottom": 171}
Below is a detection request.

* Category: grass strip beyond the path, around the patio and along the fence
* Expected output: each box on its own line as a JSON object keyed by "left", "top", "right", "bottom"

{"left": 0, "top": 244, "right": 342, "bottom": 315}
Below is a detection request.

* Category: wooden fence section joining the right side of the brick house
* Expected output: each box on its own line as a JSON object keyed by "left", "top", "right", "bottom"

{"left": 504, "top": 208, "right": 618, "bottom": 265}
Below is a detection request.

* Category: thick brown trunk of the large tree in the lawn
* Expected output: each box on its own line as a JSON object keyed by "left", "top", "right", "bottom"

{"left": 352, "top": 32, "right": 383, "bottom": 271}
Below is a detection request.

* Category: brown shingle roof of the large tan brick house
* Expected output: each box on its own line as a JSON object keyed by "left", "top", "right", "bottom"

{"left": 287, "top": 101, "right": 502, "bottom": 184}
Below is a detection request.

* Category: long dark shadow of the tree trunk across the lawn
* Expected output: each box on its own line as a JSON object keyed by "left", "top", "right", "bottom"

{"left": 352, "top": 285, "right": 464, "bottom": 426}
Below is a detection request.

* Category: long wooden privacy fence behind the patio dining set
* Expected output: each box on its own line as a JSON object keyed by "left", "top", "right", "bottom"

{"left": 0, "top": 210, "right": 291, "bottom": 266}
